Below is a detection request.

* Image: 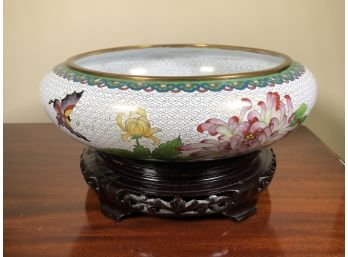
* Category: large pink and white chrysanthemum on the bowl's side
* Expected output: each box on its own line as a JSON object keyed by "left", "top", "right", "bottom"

{"left": 178, "top": 92, "right": 307, "bottom": 159}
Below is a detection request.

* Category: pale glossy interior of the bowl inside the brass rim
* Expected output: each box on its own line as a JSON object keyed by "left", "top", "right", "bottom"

{"left": 73, "top": 46, "right": 286, "bottom": 77}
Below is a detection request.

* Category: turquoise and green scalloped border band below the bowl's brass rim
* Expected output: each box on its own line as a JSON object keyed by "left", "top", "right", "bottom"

{"left": 53, "top": 62, "right": 305, "bottom": 93}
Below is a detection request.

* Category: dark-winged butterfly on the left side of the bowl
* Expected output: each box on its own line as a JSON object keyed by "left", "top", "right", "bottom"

{"left": 48, "top": 91, "right": 90, "bottom": 142}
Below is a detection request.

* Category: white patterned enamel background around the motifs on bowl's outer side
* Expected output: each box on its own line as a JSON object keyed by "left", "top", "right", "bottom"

{"left": 41, "top": 67, "right": 317, "bottom": 157}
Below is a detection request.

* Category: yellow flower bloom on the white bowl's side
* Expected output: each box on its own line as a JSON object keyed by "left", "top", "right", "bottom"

{"left": 116, "top": 108, "right": 161, "bottom": 145}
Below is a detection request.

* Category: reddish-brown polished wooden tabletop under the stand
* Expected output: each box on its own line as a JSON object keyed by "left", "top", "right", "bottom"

{"left": 4, "top": 124, "right": 344, "bottom": 257}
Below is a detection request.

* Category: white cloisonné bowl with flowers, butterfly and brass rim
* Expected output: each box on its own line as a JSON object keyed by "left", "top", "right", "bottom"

{"left": 41, "top": 45, "right": 317, "bottom": 161}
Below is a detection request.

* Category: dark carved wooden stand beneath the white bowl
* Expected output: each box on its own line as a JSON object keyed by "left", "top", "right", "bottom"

{"left": 81, "top": 148, "right": 276, "bottom": 221}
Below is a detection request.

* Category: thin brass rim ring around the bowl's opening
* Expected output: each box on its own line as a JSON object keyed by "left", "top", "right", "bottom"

{"left": 64, "top": 44, "right": 292, "bottom": 81}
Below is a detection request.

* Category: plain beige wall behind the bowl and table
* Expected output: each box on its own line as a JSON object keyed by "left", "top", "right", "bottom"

{"left": 4, "top": 0, "right": 344, "bottom": 157}
